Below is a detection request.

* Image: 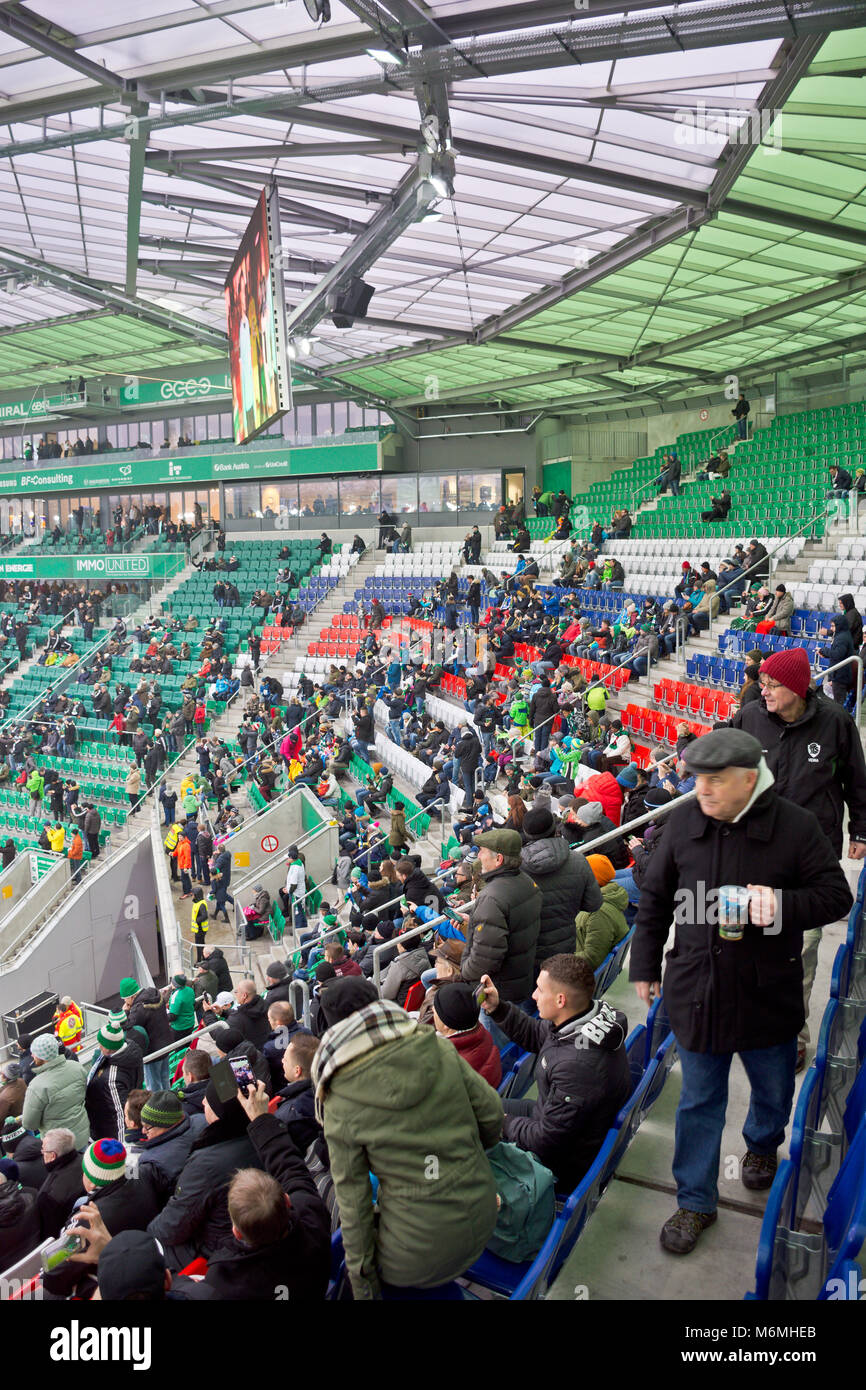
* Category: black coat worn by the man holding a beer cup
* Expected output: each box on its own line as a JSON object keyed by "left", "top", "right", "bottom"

{"left": 630, "top": 788, "right": 852, "bottom": 1052}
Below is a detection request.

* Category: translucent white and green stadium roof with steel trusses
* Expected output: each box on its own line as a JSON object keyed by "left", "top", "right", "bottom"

{"left": 0, "top": 0, "right": 866, "bottom": 411}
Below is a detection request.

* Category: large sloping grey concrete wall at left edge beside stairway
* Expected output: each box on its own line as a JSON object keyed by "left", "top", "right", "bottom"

{"left": 0, "top": 834, "right": 160, "bottom": 1039}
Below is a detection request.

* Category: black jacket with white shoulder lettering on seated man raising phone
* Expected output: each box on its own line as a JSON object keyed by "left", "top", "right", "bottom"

{"left": 492, "top": 999, "right": 631, "bottom": 1193}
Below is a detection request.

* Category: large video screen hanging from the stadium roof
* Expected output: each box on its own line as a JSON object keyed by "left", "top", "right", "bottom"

{"left": 225, "top": 189, "right": 292, "bottom": 443}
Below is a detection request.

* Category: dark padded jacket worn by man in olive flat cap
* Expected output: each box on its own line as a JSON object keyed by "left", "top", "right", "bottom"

{"left": 460, "top": 869, "right": 542, "bottom": 1001}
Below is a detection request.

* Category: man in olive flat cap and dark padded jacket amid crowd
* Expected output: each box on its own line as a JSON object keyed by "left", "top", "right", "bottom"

{"left": 459, "top": 830, "right": 542, "bottom": 1040}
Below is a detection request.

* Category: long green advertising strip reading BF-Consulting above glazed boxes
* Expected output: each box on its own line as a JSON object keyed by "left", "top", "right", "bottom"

{"left": 0, "top": 443, "right": 381, "bottom": 496}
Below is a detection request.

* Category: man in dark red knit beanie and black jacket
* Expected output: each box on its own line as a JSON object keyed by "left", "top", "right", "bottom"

{"left": 731, "top": 646, "right": 866, "bottom": 1072}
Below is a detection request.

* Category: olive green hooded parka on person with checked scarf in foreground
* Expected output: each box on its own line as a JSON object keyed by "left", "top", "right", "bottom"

{"left": 324, "top": 1029, "right": 502, "bottom": 1300}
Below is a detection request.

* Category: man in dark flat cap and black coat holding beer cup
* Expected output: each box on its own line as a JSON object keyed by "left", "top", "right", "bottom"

{"left": 630, "top": 728, "right": 852, "bottom": 1255}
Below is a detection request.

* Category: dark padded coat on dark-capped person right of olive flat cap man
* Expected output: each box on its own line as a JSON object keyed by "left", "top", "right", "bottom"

{"left": 520, "top": 835, "right": 602, "bottom": 974}
